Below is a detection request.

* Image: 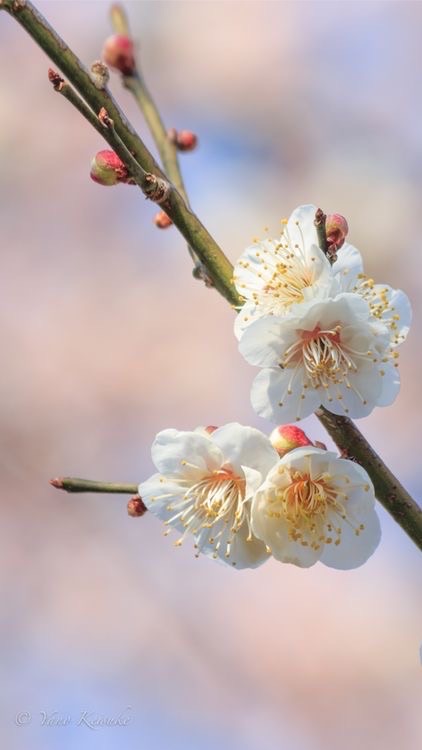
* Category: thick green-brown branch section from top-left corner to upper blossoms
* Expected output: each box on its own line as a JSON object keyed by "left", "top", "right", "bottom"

{"left": 0, "top": 0, "right": 242, "bottom": 307}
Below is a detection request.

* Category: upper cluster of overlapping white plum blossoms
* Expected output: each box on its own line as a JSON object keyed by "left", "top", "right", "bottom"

{"left": 234, "top": 205, "right": 411, "bottom": 423}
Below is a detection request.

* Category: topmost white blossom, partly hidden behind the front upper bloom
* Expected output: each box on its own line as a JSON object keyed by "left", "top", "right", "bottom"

{"left": 233, "top": 205, "right": 362, "bottom": 338}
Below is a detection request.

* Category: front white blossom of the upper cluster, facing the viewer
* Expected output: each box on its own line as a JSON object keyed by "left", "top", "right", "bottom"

{"left": 239, "top": 293, "right": 400, "bottom": 423}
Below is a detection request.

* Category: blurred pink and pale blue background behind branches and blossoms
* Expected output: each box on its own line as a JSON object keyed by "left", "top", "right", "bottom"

{"left": 0, "top": 0, "right": 422, "bottom": 750}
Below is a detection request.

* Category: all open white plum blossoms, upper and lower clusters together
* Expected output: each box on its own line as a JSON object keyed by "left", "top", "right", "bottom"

{"left": 139, "top": 206, "right": 411, "bottom": 569}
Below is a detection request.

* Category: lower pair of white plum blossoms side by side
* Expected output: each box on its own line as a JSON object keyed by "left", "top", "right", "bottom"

{"left": 139, "top": 423, "right": 380, "bottom": 569}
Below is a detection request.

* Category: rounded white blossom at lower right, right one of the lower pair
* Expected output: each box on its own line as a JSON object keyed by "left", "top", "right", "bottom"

{"left": 251, "top": 446, "right": 381, "bottom": 570}
